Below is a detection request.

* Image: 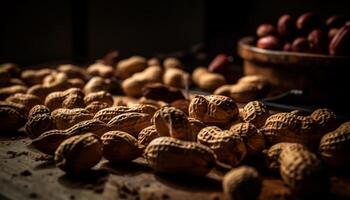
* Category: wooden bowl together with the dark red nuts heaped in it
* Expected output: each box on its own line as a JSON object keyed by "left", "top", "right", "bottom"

{"left": 238, "top": 12, "right": 350, "bottom": 102}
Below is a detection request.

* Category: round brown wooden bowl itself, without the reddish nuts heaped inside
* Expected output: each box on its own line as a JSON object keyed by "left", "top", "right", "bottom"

{"left": 238, "top": 37, "right": 350, "bottom": 102}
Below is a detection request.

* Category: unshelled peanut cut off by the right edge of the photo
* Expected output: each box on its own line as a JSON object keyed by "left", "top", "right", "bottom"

{"left": 319, "top": 122, "right": 350, "bottom": 166}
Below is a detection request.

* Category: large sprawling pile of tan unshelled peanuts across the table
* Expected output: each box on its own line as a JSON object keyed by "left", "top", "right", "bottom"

{"left": 0, "top": 61, "right": 350, "bottom": 199}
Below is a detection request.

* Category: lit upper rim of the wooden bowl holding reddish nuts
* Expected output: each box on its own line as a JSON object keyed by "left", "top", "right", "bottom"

{"left": 238, "top": 36, "right": 350, "bottom": 61}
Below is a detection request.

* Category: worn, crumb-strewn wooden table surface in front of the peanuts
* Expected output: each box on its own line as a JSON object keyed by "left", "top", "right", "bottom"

{"left": 0, "top": 133, "right": 350, "bottom": 200}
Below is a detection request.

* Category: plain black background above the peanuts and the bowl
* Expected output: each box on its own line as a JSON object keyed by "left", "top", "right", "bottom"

{"left": 0, "top": 0, "right": 350, "bottom": 65}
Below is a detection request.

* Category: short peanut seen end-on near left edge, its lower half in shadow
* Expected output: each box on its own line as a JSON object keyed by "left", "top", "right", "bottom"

{"left": 25, "top": 105, "right": 56, "bottom": 139}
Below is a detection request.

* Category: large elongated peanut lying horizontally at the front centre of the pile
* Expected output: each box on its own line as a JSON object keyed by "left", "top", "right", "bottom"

{"left": 144, "top": 137, "right": 215, "bottom": 176}
